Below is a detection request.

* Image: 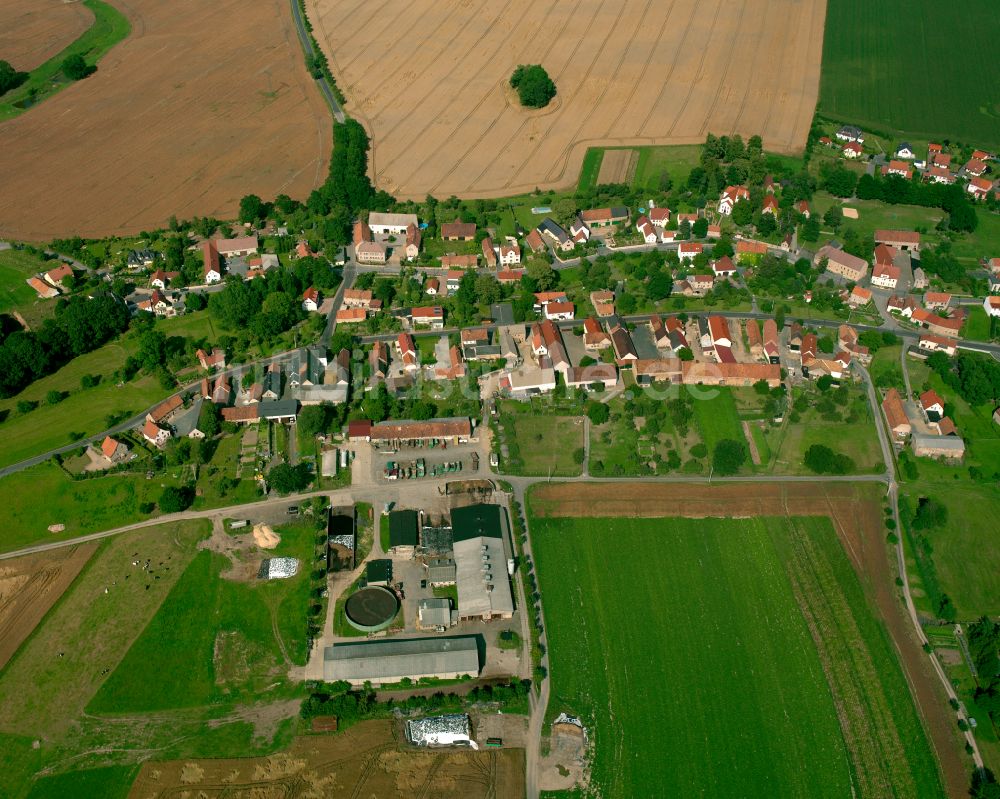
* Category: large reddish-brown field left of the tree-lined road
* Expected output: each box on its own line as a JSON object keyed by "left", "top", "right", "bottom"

{"left": 0, "top": 0, "right": 332, "bottom": 240}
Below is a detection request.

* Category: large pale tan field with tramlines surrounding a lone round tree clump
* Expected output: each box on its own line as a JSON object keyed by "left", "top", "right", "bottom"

{"left": 308, "top": 0, "right": 826, "bottom": 199}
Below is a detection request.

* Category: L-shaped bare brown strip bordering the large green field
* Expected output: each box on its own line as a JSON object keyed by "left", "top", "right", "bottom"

{"left": 529, "top": 482, "right": 968, "bottom": 796}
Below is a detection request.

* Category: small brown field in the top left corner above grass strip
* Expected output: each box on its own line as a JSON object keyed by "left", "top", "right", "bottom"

{"left": 0, "top": 0, "right": 94, "bottom": 72}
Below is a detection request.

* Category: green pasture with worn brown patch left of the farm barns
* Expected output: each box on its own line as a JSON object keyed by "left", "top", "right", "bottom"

{"left": 88, "top": 523, "right": 315, "bottom": 714}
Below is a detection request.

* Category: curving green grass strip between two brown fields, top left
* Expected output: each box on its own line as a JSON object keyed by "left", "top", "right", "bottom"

{"left": 0, "top": 0, "right": 132, "bottom": 120}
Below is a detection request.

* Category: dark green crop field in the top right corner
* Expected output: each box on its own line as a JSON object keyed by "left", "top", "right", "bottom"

{"left": 819, "top": 0, "right": 1000, "bottom": 147}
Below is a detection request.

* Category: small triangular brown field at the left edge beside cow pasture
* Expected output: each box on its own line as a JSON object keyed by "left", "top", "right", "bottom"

{"left": 0, "top": 543, "right": 97, "bottom": 669}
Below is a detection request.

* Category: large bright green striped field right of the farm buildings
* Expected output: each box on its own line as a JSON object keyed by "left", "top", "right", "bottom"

{"left": 532, "top": 518, "right": 942, "bottom": 797}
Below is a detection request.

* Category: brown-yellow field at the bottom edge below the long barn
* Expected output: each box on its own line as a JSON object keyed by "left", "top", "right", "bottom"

{"left": 129, "top": 721, "right": 524, "bottom": 799}
